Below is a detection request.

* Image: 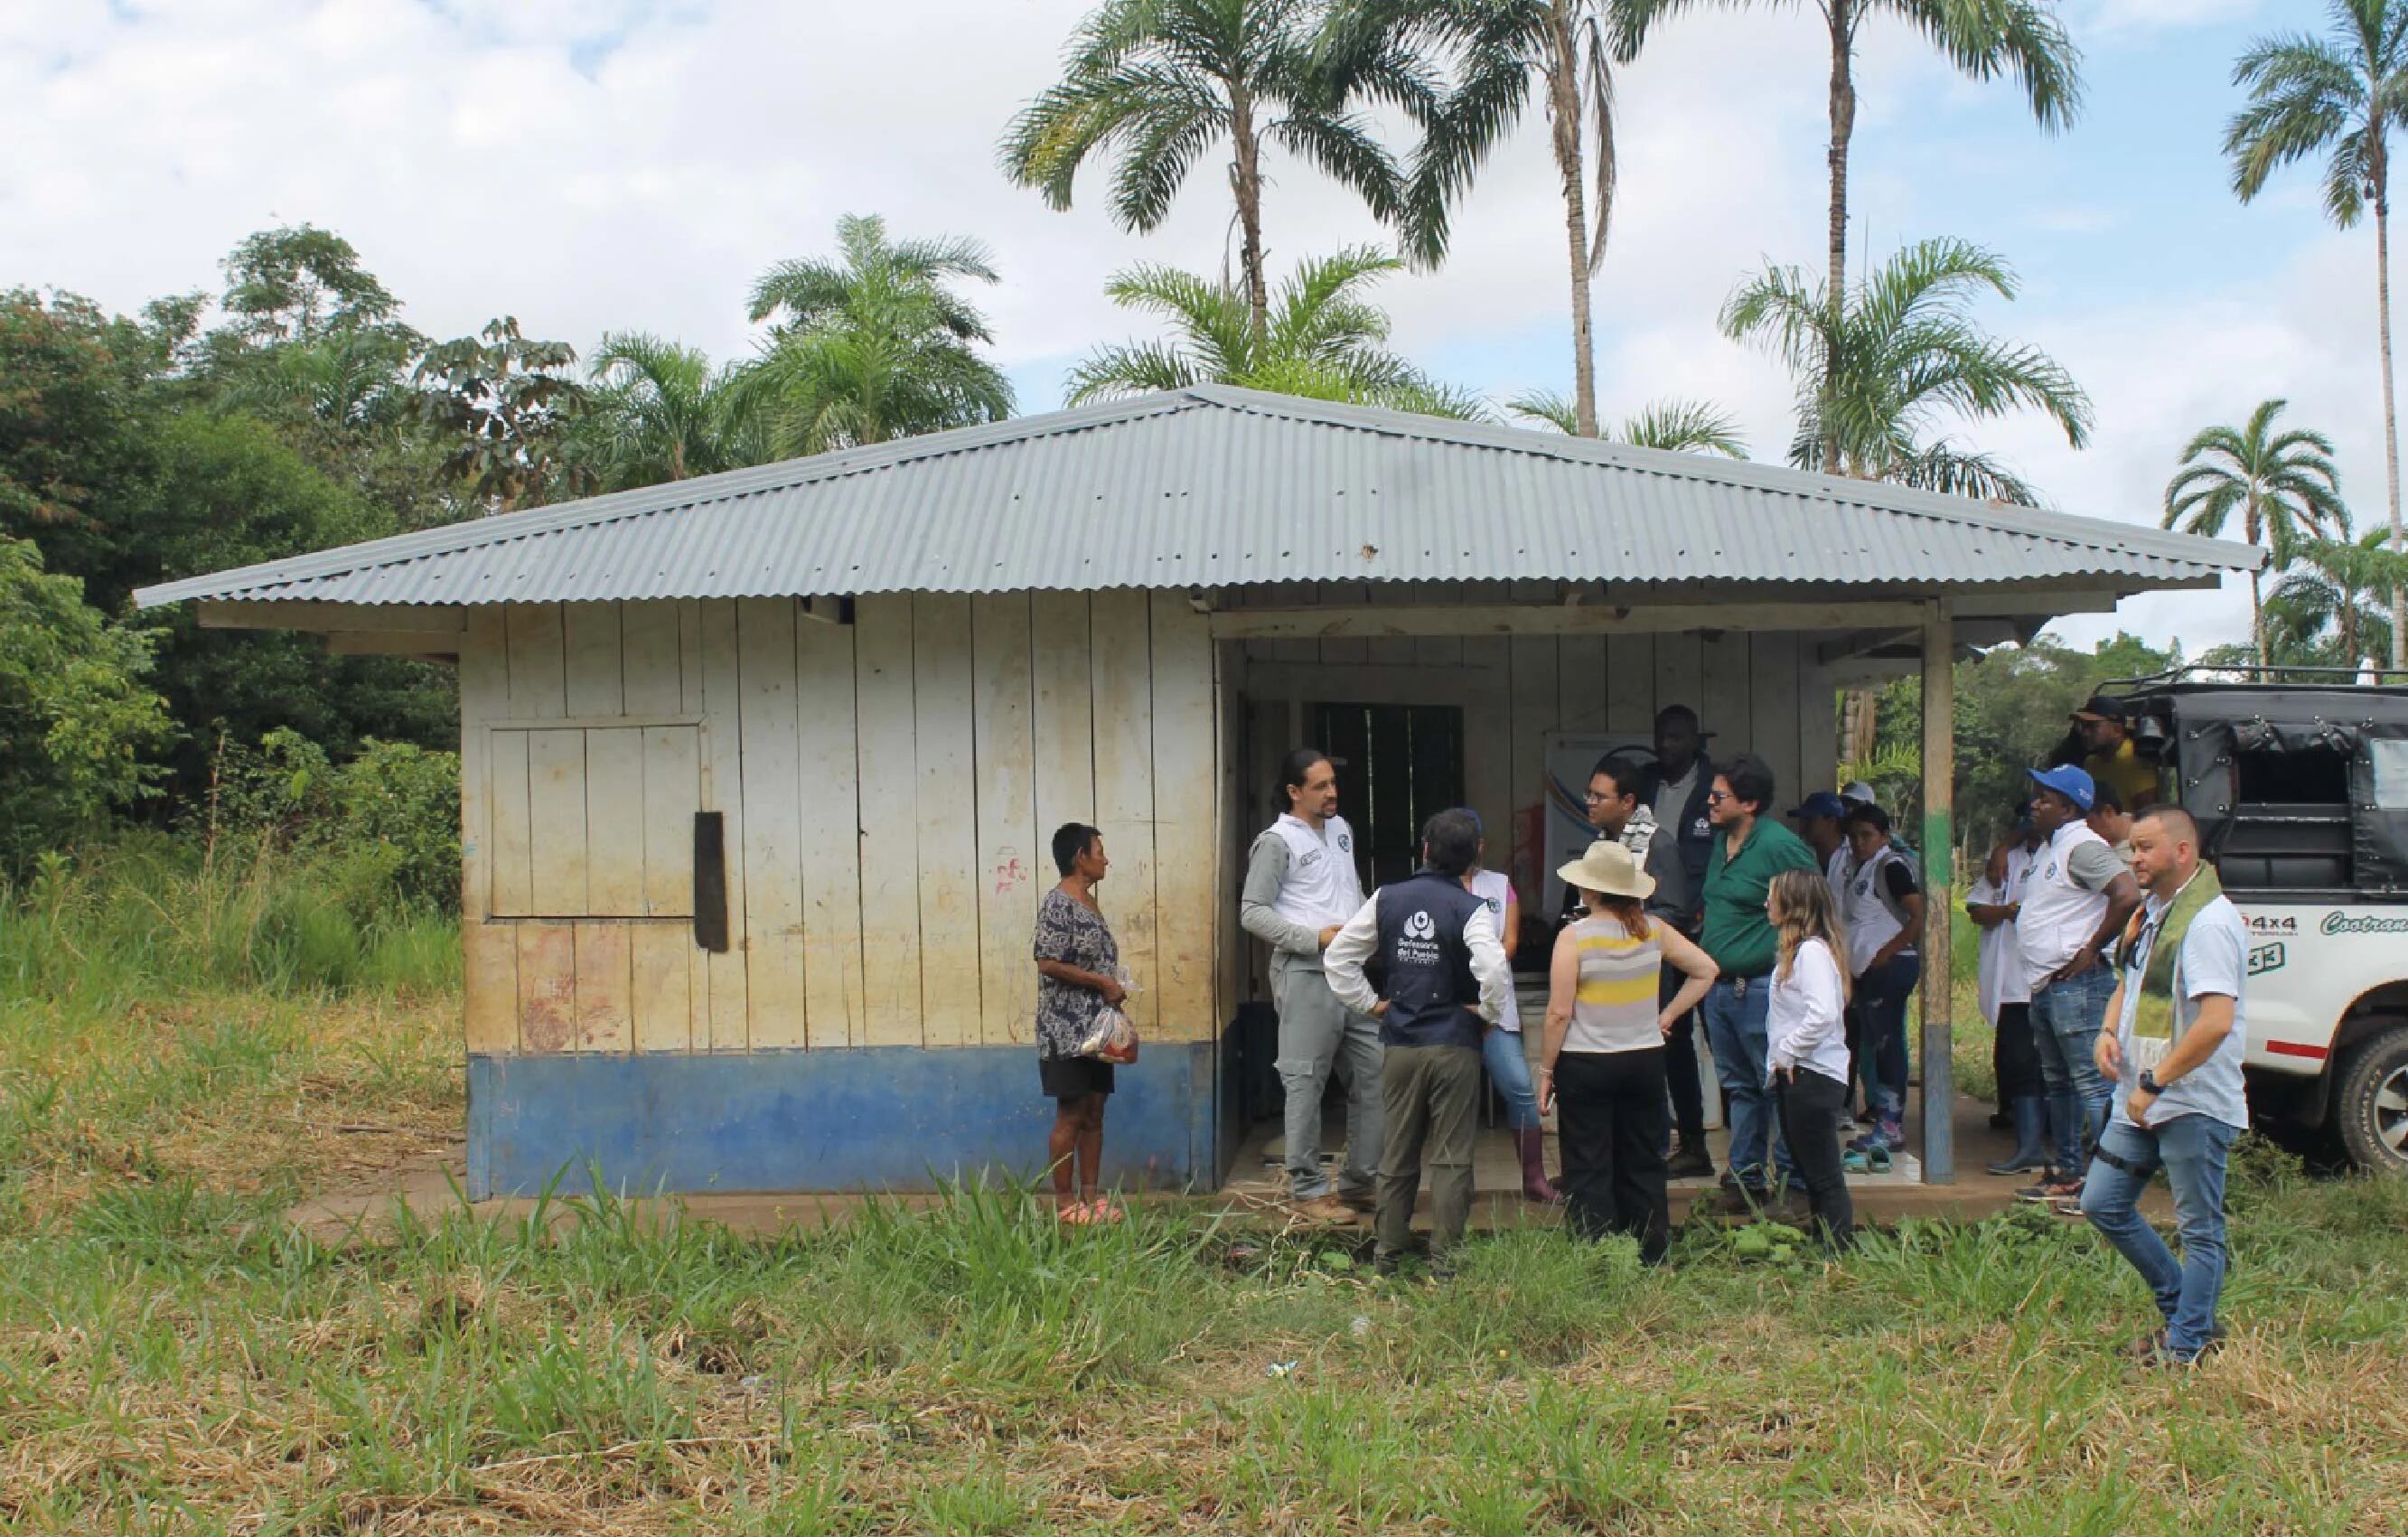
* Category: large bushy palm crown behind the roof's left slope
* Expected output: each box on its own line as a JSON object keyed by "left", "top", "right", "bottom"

{"left": 727, "top": 214, "right": 1011, "bottom": 453}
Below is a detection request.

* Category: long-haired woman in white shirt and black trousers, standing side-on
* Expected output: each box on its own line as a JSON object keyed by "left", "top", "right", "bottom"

{"left": 1765, "top": 869, "right": 1857, "bottom": 1248}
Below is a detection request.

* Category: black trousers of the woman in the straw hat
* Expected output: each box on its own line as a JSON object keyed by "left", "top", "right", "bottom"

{"left": 1556, "top": 1048, "right": 1666, "bottom": 1265}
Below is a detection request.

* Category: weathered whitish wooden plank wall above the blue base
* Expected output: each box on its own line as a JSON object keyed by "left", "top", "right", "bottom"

{"left": 460, "top": 593, "right": 1240, "bottom": 1053}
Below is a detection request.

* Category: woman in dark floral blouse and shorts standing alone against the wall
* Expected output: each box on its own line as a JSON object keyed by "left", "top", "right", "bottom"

{"left": 1035, "top": 821, "right": 1127, "bottom": 1223}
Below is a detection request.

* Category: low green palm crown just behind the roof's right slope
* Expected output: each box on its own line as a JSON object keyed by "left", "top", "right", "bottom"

{"left": 1721, "top": 241, "right": 2090, "bottom": 506}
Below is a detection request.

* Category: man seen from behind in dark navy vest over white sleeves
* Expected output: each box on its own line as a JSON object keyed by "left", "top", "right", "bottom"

{"left": 1322, "top": 811, "right": 1513, "bottom": 1274}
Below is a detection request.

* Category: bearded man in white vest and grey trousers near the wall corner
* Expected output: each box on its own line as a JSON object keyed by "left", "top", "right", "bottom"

{"left": 1238, "top": 747, "right": 1380, "bottom": 1223}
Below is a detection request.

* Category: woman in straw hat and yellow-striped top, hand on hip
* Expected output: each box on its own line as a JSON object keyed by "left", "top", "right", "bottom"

{"left": 1539, "top": 839, "right": 1719, "bottom": 1265}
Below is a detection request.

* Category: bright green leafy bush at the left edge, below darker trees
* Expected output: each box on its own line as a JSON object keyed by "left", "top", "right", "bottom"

{"left": 0, "top": 538, "right": 169, "bottom": 875}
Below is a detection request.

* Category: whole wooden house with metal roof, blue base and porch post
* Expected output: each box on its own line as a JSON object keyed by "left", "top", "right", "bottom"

{"left": 140, "top": 388, "right": 2256, "bottom": 1197}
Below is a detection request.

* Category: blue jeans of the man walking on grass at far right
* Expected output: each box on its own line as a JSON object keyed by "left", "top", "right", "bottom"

{"left": 2083, "top": 1115, "right": 2239, "bottom": 1361}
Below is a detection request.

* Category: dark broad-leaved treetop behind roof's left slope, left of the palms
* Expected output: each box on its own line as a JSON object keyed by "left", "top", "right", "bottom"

{"left": 414, "top": 315, "right": 578, "bottom": 513}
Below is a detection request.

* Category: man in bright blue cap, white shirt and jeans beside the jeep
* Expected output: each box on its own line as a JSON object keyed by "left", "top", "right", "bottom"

{"left": 2016, "top": 764, "right": 2141, "bottom": 1204}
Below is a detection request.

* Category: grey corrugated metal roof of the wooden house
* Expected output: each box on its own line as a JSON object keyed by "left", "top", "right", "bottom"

{"left": 135, "top": 386, "right": 2261, "bottom": 607}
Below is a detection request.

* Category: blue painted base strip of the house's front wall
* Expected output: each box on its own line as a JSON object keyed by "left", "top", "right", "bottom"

{"left": 467, "top": 1041, "right": 1235, "bottom": 1200}
